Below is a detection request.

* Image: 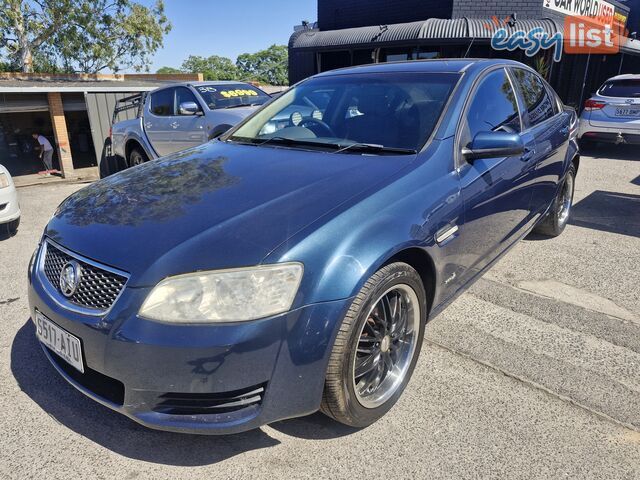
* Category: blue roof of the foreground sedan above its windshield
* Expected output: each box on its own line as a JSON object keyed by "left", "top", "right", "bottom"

{"left": 316, "top": 58, "right": 528, "bottom": 77}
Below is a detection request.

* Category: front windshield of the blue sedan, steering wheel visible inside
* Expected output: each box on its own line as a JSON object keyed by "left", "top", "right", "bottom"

{"left": 225, "top": 72, "right": 460, "bottom": 154}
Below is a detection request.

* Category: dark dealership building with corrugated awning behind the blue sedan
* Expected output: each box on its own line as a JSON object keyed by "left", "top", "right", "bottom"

{"left": 289, "top": 0, "right": 640, "bottom": 107}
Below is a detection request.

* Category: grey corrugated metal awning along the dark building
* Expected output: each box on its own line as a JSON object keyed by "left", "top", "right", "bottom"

{"left": 289, "top": 17, "right": 562, "bottom": 49}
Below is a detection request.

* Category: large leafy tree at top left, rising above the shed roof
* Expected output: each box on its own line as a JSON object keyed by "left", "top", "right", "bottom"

{"left": 0, "top": 0, "right": 171, "bottom": 73}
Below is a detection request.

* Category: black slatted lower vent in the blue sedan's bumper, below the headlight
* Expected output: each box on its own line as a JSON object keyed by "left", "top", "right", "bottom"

{"left": 153, "top": 384, "right": 266, "bottom": 415}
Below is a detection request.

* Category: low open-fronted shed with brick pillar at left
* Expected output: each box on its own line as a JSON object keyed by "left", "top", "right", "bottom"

{"left": 0, "top": 73, "right": 202, "bottom": 184}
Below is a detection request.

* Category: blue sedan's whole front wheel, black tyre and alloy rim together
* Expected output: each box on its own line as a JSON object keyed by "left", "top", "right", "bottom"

{"left": 321, "top": 263, "right": 427, "bottom": 427}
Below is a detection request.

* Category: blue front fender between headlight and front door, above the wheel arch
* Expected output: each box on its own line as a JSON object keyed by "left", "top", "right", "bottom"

{"left": 263, "top": 142, "right": 462, "bottom": 306}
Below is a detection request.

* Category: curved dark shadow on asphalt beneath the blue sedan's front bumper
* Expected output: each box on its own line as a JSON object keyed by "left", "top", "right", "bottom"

{"left": 11, "top": 320, "right": 280, "bottom": 466}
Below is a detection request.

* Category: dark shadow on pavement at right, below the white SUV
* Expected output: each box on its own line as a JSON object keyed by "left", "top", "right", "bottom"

{"left": 569, "top": 190, "right": 640, "bottom": 237}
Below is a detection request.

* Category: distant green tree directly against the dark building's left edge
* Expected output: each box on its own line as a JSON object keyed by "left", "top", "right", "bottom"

{"left": 236, "top": 45, "right": 289, "bottom": 85}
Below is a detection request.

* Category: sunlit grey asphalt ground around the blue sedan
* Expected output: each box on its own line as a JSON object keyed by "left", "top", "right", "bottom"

{"left": 0, "top": 147, "right": 640, "bottom": 479}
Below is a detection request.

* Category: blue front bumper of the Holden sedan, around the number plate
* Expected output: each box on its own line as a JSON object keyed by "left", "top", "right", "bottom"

{"left": 29, "top": 258, "right": 350, "bottom": 434}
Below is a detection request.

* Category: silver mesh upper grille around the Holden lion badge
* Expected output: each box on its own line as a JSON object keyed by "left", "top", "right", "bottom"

{"left": 44, "top": 242, "right": 127, "bottom": 311}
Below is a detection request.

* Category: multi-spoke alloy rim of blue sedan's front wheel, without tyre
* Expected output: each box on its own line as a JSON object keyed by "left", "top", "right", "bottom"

{"left": 352, "top": 284, "right": 421, "bottom": 408}
